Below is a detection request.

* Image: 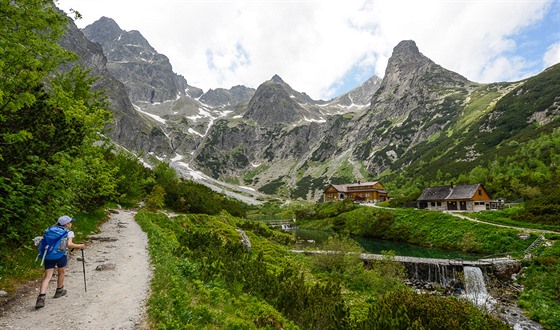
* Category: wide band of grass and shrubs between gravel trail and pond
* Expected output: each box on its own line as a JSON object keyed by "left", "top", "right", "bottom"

{"left": 136, "top": 211, "right": 507, "bottom": 330}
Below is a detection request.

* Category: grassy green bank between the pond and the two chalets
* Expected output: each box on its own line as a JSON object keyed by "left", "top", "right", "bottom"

{"left": 303, "top": 206, "right": 536, "bottom": 255}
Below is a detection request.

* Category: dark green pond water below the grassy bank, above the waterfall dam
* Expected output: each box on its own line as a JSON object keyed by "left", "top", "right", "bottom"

{"left": 289, "top": 228, "right": 483, "bottom": 260}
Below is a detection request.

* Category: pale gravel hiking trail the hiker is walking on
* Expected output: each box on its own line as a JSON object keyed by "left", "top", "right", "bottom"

{"left": 0, "top": 210, "right": 151, "bottom": 330}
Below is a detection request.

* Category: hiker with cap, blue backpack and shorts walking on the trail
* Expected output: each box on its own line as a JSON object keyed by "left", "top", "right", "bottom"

{"left": 35, "top": 215, "right": 86, "bottom": 308}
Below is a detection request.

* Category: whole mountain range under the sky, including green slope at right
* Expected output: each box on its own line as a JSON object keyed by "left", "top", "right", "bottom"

{"left": 66, "top": 14, "right": 559, "bottom": 200}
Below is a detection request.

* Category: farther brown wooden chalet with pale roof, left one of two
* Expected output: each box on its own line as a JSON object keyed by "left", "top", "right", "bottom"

{"left": 324, "top": 181, "right": 387, "bottom": 203}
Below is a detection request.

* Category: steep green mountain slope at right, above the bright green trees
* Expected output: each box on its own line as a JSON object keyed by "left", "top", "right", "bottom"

{"left": 389, "top": 64, "right": 560, "bottom": 184}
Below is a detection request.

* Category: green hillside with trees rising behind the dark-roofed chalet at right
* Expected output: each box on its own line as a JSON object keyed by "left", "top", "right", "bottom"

{"left": 381, "top": 65, "right": 560, "bottom": 200}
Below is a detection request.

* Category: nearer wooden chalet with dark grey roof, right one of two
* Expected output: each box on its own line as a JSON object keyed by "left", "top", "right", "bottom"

{"left": 417, "top": 184, "right": 503, "bottom": 212}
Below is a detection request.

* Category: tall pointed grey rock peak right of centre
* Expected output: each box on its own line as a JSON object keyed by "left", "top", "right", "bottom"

{"left": 346, "top": 40, "right": 479, "bottom": 173}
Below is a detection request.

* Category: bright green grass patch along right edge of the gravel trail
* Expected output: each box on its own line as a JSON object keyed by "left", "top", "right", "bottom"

{"left": 136, "top": 211, "right": 299, "bottom": 330}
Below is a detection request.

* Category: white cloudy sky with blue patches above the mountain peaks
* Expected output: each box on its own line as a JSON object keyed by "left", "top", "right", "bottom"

{"left": 57, "top": 0, "right": 560, "bottom": 99}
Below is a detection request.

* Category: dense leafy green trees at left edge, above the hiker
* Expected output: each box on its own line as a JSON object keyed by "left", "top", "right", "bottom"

{"left": 0, "top": 0, "right": 115, "bottom": 260}
